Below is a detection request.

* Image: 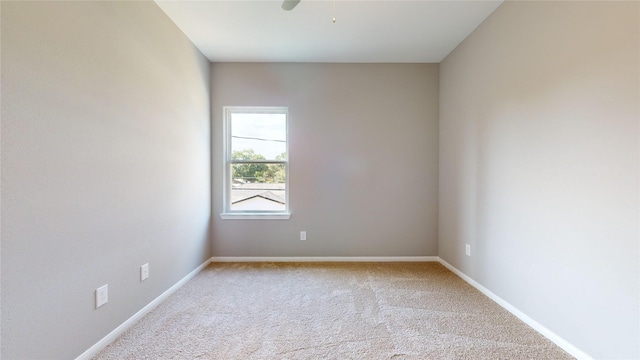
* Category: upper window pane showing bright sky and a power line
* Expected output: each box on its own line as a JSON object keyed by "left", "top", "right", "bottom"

{"left": 231, "top": 113, "right": 287, "bottom": 160}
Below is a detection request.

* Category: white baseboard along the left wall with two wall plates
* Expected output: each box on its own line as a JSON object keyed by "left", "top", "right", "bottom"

{"left": 76, "top": 259, "right": 211, "bottom": 360}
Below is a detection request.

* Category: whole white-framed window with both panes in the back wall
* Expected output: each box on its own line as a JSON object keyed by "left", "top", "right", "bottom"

{"left": 221, "top": 107, "right": 290, "bottom": 219}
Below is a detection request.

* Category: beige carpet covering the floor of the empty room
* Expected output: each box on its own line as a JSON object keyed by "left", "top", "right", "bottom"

{"left": 95, "top": 263, "right": 572, "bottom": 359}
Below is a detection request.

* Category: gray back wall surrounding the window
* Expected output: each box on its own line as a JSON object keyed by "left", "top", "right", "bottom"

{"left": 211, "top": 63, "right": 438, "bottom": 256}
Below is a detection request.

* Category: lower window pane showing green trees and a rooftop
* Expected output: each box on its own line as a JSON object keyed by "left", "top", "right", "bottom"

{"left": 231, "top": 164, "right": 286, "bottom": 211}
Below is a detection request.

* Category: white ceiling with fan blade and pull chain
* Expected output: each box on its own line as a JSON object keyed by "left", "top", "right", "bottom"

{"left": 156, "top": 0, "right": 502, "bottom": 63}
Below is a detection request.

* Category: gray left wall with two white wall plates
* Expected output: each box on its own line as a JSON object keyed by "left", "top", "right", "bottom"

{"left": 1, "top": 1, "right": 211, "bottom": 359}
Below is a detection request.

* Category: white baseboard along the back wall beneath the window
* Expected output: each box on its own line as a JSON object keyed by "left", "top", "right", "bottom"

{"left": 211, "top": 256, "right": 439, "bottom": 262}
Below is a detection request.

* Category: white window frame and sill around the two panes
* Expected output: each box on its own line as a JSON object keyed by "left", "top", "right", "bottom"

{"left": 220, "top": 106, "right": 291, "bottom": 220}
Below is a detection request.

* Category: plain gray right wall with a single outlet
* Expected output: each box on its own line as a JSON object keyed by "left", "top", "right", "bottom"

{"left": 439, "top": 2, "right": 640, "bottom": 359}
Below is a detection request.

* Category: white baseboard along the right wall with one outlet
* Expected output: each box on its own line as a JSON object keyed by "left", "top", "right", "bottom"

{"left": 439, "top": 258, "right": 594, "bottom": 360}
